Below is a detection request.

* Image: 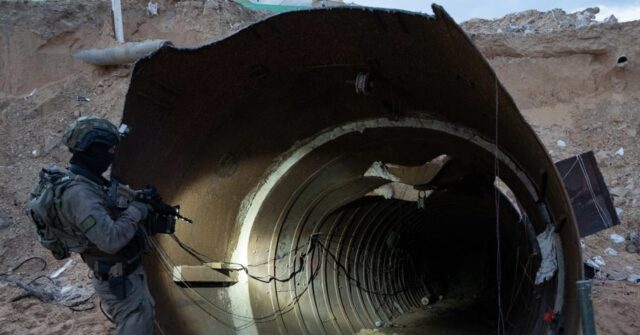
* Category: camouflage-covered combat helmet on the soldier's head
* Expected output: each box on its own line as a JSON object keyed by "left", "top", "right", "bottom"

{"left": 62, "top": 116, "right": 120, "bottom": 152}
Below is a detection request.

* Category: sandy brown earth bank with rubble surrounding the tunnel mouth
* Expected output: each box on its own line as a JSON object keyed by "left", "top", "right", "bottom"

{"left": 0, "top": 0, "right": 640, "bottom": 334}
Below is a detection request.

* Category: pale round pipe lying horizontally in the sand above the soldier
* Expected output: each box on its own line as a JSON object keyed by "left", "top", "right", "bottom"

{"left": 73, "top": 40, "right": 173, "bottom": 65}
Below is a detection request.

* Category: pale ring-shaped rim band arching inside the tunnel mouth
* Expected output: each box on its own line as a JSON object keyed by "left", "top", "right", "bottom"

{"left": 229, "top": 116, "right": 565, "bottom": 334}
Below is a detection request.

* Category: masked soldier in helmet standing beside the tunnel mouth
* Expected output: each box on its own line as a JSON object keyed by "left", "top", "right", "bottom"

{"left": 32, "top": 117, "right": 155, "bottom": 334}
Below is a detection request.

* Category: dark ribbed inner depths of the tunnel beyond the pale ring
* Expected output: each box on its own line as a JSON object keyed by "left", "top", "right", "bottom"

{"left": 245, "top": 169, "right": 549, "bottom": 334}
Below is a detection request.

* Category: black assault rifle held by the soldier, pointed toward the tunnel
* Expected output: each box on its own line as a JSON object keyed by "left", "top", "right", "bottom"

{"left": 109, "top": 178, "right": 193, "bottom": 235}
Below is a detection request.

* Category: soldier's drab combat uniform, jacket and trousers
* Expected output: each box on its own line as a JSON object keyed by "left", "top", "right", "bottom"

{"left": 60, "top": 175, "right": 155, "bottom": 334}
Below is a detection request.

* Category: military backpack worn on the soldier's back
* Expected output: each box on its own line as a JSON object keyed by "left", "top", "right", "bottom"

{"left": 28, "top": 165, "right": 87, "bottom": 260}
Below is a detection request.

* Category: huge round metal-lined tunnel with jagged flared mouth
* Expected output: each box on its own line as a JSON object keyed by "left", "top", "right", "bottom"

{"left": 113, "top": 6, "right": 582, "bottom": 334}
